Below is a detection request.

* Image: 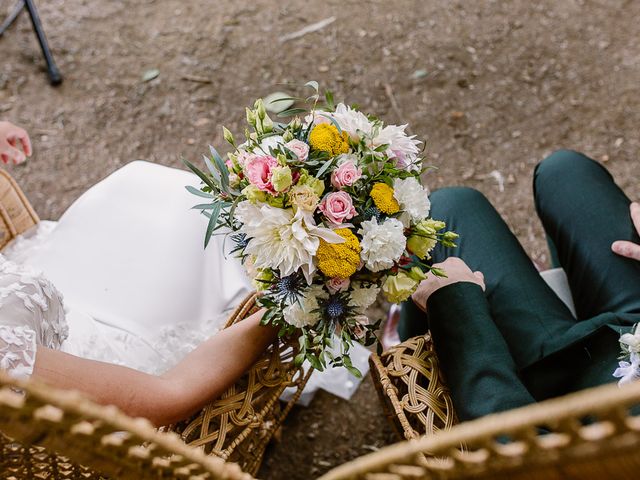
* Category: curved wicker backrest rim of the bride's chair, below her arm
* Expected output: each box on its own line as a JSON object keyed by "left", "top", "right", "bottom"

{"left": 0, "top": 371, "right": 252, "bottom": 480}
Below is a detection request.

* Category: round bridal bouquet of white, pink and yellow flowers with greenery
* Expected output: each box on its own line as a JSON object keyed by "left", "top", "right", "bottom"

{"left": 185, "top": 82, "right": 457, "bottom": 375}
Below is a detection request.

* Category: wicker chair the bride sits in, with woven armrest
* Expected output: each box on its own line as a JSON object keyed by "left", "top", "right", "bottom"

{"left": 0, "top": 170, "right": 311, "bottom": 480}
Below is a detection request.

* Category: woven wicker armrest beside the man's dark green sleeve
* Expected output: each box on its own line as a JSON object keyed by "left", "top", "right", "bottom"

{"left": 369, "top": 334, "right": 457, "bottom": 440}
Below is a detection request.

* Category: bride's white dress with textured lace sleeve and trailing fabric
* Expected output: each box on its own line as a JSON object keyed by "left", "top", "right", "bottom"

{"left": 0, "top": 161, "right": 369, "bottom": 404}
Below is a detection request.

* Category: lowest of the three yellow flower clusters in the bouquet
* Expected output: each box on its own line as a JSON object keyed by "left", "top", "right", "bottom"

{"left": 316, "top": 228, "right": 361, "bottom": 278}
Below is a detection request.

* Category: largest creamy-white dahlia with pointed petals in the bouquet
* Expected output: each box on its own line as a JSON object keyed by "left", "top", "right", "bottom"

{"left": 235, "top": 200, "right": 344, "bottom": 284}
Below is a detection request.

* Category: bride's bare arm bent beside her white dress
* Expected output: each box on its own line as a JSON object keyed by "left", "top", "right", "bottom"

{"left": 33, "top": 311, "right": 277, "bottom": 425}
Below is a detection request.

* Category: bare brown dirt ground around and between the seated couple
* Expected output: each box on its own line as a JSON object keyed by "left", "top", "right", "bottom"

{"left": 0, "top": 0, "right": 640, "bottom": 480}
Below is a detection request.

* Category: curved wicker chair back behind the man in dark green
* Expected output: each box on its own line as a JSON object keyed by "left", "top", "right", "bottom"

{"left": 320, "top": 382, "right": 640, "bottom": 480}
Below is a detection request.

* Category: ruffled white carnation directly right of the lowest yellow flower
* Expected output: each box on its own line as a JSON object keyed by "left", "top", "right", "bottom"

{"left": 358, "top": 218, "right": 407, "bottom": 272}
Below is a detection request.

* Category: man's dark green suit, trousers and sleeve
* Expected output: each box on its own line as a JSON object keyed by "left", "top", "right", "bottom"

{"left": 399, "top": 151, "right": 640, "bottom": 420}
